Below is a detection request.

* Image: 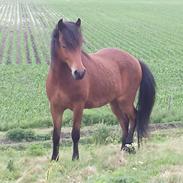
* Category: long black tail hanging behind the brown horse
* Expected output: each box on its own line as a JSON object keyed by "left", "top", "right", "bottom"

{"left": 136, "top": 61, "right": 156, "bottom": 147}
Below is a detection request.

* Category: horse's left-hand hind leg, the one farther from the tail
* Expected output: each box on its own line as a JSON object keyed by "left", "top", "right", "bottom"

{"left": 110, "top": 101, "right": 129, "bottom": 149}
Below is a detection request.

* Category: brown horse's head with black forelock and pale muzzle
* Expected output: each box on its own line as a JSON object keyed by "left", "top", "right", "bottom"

{"left": 57, "top": 18, "right": 86, "bottom": 80}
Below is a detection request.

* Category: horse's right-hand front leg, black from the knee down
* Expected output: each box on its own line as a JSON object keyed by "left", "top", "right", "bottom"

{"left": 72, "top": 105, "right": 84, "bottom": 160}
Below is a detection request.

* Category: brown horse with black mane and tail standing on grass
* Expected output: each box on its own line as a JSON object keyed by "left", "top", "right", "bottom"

{"left": 46, "top": 19, "right": 155, "bottom": 160}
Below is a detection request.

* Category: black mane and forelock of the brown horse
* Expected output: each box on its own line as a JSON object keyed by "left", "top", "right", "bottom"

{"left": 51, "top": 22, "right": 83, "bottom": 58}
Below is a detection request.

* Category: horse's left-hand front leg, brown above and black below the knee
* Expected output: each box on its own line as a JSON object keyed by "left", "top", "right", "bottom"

{"left": 50, "top": 105, "right": 64, "bottom": 161}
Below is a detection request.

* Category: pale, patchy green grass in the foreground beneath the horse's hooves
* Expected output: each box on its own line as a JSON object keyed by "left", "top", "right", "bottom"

{"left": 0, "top": 125, "right": 183, "bottom": 183}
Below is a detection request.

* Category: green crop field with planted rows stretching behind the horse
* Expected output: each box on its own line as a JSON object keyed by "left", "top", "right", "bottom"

{"left": 0, "top": 0, "right": 183, "bottom": 130}
